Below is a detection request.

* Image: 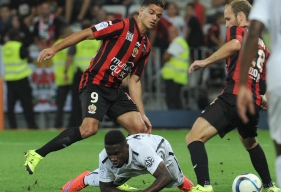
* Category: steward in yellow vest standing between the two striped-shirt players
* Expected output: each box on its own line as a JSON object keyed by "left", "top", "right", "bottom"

{"left": 162, "top": 26, "right": 189, "bottom": 109}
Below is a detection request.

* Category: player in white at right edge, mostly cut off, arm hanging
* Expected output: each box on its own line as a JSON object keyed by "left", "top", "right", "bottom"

{"left": 237, "top": 0, "right": 281, "bottom": 187}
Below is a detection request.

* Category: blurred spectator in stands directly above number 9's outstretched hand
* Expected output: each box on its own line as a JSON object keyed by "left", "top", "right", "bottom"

{"left": 33, "top": 2, "right": 61, "bottom": 50}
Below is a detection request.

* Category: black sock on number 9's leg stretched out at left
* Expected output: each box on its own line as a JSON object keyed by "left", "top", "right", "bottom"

{"left": 36, "top": 127, "right": 82, "bottom": 157}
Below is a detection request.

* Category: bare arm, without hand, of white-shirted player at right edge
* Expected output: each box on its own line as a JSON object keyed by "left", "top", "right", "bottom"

{"left": 239, "top": 30, "right": 259, "bottom": 85}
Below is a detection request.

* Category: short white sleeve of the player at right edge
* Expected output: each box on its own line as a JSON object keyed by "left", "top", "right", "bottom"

{"left": 249, "top": 0, "right": 272, "bottom": 28}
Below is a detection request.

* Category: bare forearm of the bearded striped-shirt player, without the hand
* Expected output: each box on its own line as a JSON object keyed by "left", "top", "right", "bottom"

{"left": 206, "top": 39, "right": 241, "bottom": 64}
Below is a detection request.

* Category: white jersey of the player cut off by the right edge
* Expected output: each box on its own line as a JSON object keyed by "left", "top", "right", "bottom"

{"left": 249, "top": 0, "right": 281, "bottom": 91}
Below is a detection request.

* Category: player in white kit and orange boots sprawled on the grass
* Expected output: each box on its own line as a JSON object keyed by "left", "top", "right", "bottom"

{"left": 62, "top": 130, "right": 193, "bottom": 192}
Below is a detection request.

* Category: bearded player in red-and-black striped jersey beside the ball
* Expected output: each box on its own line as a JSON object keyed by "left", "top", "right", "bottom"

{"left": 186, "top": 0, "right": 280, "bottom": 192}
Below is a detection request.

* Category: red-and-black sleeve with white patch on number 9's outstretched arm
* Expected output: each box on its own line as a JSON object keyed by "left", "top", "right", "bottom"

{"left": 91, "top": 19, "right": 125, "bottom": 40}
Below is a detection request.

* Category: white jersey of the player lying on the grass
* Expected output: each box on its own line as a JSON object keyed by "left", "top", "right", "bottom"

{"left": 99, "top": 134, "right": 183, "bottom": 187}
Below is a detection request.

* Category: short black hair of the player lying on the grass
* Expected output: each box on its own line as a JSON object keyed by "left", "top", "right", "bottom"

{"left": 104, "top": 130, "right": 127, "bottom": 145}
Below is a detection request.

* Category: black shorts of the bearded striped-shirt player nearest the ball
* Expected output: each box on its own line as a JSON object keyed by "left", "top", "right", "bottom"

{"left": 199, "top": 94, "right": 261, "bottom": 139}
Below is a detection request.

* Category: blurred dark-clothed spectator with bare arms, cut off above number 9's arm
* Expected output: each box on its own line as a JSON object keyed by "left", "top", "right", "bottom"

{"left": 65, "top": 0, "right": 91, "bottom": 24}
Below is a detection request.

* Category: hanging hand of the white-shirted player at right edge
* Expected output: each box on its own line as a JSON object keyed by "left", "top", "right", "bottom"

{"left": 237, "top": 85, "right": 255, "bottom": 123}
